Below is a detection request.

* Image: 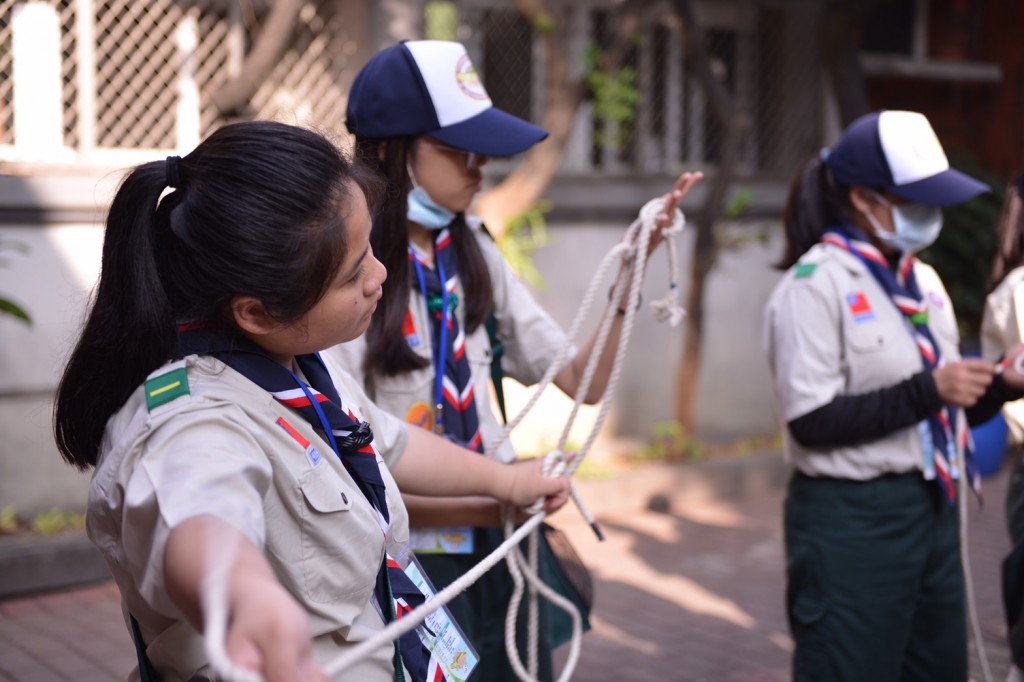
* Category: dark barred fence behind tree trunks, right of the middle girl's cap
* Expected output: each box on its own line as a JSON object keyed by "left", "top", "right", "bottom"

{"left": 454, "top": 0, "right": 817, "bottom": 176}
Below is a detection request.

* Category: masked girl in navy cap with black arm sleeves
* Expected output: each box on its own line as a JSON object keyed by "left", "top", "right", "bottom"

{"left": 764, "top": 112, "right": 1024, "bottom": 682}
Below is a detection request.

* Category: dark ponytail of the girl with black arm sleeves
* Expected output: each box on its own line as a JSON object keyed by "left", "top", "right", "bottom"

{"left": 775, "top": 156, "right": 852, "bottom": 270}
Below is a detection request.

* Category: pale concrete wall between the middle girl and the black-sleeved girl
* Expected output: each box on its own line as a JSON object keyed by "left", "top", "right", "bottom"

{"left": 536, "top": 214, "right": 781, "bottom": 440}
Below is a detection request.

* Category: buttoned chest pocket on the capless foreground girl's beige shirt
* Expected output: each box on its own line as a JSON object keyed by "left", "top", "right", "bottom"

{"left": 298, "top": 467, "right": 384, "bottom": 603}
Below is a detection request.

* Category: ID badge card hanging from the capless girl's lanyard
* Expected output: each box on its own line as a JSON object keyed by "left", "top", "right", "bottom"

{"left": 396, "top": 548, "right": 480, "bottom": 682}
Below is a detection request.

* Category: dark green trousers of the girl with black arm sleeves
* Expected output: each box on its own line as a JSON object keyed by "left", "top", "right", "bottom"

{"left": 784, "top": 473, "right": 968, "bottom": 682}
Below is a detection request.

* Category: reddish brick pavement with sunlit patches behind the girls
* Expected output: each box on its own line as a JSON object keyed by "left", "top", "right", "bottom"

{"left": 0, "top": 462, "right": 1008, "bottom": 682}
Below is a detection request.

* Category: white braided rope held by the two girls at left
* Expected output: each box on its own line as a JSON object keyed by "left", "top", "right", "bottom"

{"left": 203, "top": 198, "right": 685, "bottom": 682}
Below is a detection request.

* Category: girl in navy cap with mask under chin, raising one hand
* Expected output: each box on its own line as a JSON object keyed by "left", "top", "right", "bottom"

{"left": 336, "top": 41, "right": 700, "bottom": 682}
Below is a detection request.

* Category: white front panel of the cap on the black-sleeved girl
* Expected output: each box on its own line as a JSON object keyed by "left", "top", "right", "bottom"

{"left": 879, "top": 112, "right": 949, "bottom": 185}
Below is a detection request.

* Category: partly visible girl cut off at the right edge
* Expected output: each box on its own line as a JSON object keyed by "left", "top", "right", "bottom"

{"left": 981, "top": 172, "right": 1024, "bottom": 682}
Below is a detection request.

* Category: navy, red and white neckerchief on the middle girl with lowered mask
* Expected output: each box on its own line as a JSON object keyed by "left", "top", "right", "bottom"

{"left": 406, "top": 228, "right": 483, "bottom": 453}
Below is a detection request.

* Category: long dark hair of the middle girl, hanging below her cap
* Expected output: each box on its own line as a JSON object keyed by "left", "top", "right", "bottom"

{"left": 355, "top": 137, "right": 494, "bottom": 376}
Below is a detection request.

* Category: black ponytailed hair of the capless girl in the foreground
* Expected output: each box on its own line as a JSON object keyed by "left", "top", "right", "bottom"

{"left": 54, "top": 121, "right": 376, "bottom": 469}
